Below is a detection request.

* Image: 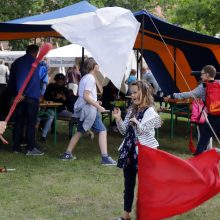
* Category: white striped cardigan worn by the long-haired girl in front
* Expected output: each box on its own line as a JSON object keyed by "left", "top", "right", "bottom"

{"left": 116, "top": 107, "right": 161, "bottom": 148}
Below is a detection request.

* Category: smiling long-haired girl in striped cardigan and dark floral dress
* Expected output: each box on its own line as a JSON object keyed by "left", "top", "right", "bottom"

{"left": 112, "top": 81, "right": 161, "bottom": 220}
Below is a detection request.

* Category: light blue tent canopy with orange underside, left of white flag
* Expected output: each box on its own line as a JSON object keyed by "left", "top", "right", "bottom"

{"left": 0, "top": 1, "right": 97, "bottom": 40}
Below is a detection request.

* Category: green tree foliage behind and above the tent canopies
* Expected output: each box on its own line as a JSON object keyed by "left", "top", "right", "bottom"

{"left": 0, "top": 0, "right": 220, "bottom": 50}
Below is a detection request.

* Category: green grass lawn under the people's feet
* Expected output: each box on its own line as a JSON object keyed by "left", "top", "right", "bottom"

{"left": 0, "top": 115, "right": 220, "bottom": 220}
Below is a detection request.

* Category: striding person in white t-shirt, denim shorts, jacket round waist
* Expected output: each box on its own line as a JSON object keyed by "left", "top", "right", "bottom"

{"left": 60, "top": 58, "right": 116, "bottom": 165}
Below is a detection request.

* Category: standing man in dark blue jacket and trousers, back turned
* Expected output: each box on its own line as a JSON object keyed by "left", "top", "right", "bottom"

{"left": 9, "top": 45, "right": 43, "bottom": 155}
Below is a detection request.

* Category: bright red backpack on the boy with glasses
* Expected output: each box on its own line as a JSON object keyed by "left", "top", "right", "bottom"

{"left": 205, "top": 80, "right": 220, "bottom": 115}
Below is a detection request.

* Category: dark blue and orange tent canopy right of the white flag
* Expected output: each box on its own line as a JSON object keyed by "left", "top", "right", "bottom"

{"left": 134, "top": 10, "right": 220, "bottom": 94}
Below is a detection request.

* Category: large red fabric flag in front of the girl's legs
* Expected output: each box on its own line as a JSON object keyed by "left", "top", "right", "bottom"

{"left": 137, "top": 144, "right": 220, "bottom": 220}
